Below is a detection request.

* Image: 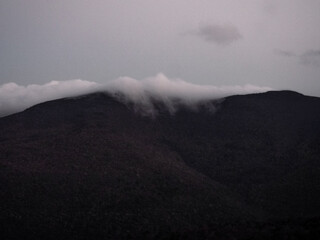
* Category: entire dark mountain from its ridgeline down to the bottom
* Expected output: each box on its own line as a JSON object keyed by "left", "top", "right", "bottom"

{"left": 0, "top": 91, "right": 320, "bottom": 239}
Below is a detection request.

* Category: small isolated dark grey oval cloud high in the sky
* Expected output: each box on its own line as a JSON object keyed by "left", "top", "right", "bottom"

{"left": 192, "top": 24, "right": 242, "bottom": 45}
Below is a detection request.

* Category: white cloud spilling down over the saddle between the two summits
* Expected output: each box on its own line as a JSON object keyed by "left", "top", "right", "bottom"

{"left": 105, "top": 73, "right": 271, "bottom": 115}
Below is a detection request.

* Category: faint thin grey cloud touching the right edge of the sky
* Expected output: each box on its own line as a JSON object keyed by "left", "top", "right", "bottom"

{"left": 274, "top": 49, "right": 320, "bottom": 67}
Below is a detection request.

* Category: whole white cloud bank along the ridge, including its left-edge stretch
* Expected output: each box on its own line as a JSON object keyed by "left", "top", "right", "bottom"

{"left": 0, "top": 73, "right": 271, "bottom": 116}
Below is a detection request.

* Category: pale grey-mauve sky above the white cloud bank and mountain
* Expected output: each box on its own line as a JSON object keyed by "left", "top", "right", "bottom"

{"left": 0, "top": 0, "right": 320, "bottom": 96}
